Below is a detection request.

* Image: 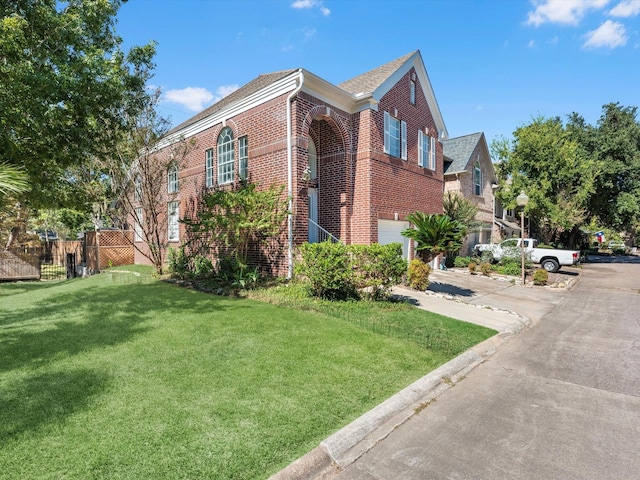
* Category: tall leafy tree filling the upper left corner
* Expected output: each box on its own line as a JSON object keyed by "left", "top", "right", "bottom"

{"left": 0, "top": 0, "right": 155, "bottom": 207}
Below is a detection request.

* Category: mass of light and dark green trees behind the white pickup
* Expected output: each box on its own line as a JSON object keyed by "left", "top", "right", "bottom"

{"left": 491, "top": 104, "right": 640, "bottom": 246}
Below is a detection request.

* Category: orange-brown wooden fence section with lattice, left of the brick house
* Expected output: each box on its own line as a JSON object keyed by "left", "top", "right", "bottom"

{"left": 84, "top": 230, "right": 133, "bottom": 272}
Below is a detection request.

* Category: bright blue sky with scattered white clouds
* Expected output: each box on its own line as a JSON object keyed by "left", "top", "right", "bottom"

{"left": 117, "top": 0, "right": 640, "bottom": 149}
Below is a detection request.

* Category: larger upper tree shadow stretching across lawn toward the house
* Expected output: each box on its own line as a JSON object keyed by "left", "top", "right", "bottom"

{"left": 0, "top": 282, "right": 235, "bottom": 372}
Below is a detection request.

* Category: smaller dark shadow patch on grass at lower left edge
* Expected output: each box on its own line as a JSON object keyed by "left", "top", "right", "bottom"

{"left": 0, "top": 369, "right": 108, "bottom": 445}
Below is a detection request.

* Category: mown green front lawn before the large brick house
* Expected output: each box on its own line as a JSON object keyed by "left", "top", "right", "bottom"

{"left": 0, "top": 267, "right": 494, "bottom": 480}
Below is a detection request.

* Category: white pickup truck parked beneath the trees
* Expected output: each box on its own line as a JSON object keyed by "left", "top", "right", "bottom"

{"left": 473, "top": 238, "right": 580, "bottom": 273}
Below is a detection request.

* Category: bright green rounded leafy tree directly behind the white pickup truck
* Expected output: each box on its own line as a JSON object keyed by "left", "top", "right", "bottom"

{"left": 491, "top": 117, "right": 599, "bottom": 245}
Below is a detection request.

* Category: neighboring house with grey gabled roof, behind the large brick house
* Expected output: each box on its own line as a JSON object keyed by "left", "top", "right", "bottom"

{"left": 443, "top": 132, "right": 499, "bottom": 255}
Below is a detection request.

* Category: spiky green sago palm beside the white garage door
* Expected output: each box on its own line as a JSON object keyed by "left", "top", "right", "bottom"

{"left": 402, "top": 212, "right": 466, "bottom": 263}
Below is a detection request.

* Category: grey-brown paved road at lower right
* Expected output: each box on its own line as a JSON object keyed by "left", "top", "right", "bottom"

{"left": 335, "top": 263, "right": 640, "bottom": 480}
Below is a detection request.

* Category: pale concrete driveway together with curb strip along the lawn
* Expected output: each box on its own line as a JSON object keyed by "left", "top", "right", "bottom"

{"left": 271, "top": 271, "right": 579, "bottom": 480}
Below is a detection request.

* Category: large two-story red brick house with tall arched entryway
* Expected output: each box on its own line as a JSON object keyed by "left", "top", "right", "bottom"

{"left": 136, "top": 51, "right": 447, "bottom": 276}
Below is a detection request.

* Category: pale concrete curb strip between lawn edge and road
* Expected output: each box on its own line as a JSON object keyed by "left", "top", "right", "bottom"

{"left": 269, "top": 324, "right": 532, "bottom": 480}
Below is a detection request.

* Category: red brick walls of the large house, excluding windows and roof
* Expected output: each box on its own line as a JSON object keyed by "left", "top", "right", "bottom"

{"left": 136, "top": 70, "right": 443, "bottom": 274}
